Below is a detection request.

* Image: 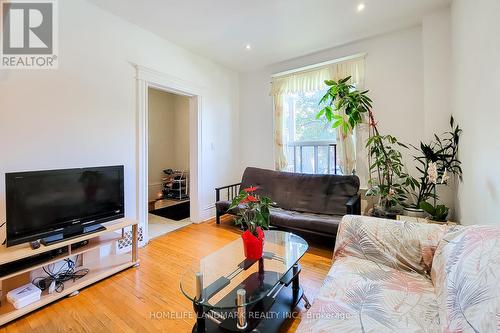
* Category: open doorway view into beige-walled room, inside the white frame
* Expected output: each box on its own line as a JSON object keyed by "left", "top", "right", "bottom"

{"left": 148, "top": 87, "right": 191, "bottom": 239}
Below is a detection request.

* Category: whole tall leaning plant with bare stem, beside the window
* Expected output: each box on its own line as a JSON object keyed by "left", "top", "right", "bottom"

{"left": 316, "top": 77, "right": 411, "bottom": 218}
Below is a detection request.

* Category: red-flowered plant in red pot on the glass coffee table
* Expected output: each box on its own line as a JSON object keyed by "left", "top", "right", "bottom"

{"left": 229, "top": 186, "right": 273, "bottom": 260}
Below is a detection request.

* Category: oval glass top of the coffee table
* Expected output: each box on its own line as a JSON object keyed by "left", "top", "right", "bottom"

{"left": 181, "top": 230, "right": 308, "bottom": 309}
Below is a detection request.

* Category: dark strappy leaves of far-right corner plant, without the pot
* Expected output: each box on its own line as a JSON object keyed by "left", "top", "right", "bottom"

{"left": 408, "top": 117, "right": 462, "bottom": 209}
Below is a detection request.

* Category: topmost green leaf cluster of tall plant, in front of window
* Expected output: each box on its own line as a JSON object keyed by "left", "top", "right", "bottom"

{"left": 316, "top": 76, "right": 372, "bottom": 135}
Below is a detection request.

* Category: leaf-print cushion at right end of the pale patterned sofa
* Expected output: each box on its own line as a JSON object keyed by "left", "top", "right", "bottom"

{"left": 431, "top": 226, "right": 500, "bottom": 332}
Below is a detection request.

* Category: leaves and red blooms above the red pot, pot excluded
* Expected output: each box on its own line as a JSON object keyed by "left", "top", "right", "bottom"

{"left": 228, "top": 190, "right": 274, "bottom": 236}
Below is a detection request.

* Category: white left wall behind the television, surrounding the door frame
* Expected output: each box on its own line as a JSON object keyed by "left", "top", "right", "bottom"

{"left": 0, "top": 0, "right": 240, "bottom": 240}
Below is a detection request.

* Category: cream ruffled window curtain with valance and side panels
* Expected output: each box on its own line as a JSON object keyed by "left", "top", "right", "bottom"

{"left": 271, "top": 56, "right": 368, "bottom": 178}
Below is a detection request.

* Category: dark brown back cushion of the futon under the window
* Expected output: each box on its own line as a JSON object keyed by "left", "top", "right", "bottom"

{"left": 241, "top": 167, "right": 359, "bottom": 215}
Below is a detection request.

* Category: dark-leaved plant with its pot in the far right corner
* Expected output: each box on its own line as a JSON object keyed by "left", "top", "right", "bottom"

{"left": 405, "top": 117, "right": 462, "bottom": 217}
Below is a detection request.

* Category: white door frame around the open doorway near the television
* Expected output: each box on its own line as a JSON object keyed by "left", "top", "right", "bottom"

{"left": 133, "top": 64, "right": 205, "bottom": 245}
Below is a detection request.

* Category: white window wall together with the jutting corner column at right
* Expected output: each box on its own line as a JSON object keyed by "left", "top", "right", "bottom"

{"left": 240, "top": 14, "right": 456, "bottom": 211}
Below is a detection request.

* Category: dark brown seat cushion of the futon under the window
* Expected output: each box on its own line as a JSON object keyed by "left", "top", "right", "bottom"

{"left": 269, "top": 208, "right": 342, "bottom": 236}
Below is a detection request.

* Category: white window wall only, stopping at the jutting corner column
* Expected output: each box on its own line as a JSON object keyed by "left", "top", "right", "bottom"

{"left": 240, "top": 27, "right": 424, "bottom": 184}
